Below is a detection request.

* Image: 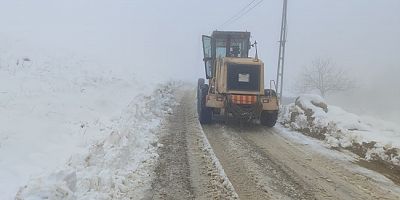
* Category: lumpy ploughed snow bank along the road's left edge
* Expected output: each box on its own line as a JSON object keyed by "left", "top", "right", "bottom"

{"left": 17, "top": 83, "right": 175, "bottom": 199}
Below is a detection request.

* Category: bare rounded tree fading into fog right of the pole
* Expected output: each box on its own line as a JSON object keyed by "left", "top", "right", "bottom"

{"left": 295, "top": 59, "right": 354, "bottom": 97}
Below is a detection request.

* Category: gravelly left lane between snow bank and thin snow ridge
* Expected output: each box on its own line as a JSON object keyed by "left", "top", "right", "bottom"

{"left": 152, "top": 91, "right": 238, "bottom": 199}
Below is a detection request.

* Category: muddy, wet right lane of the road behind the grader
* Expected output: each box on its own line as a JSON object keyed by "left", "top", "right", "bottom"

{"left": 203, "top": 125, "right": 400, "bottom": 199}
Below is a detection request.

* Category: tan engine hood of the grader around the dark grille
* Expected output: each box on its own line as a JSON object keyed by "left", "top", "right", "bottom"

{"left": 216, "top": 58, "right": 264, "bottom": 95}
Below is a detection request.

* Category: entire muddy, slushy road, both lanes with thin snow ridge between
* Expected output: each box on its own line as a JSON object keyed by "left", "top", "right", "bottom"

{"left": 152, "top": 92, "right": 400, "bottom": 199}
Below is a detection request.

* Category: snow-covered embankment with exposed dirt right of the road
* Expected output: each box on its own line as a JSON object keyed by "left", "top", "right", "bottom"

{"left": 281, "top": 95, "right": 400, "bottom": 166}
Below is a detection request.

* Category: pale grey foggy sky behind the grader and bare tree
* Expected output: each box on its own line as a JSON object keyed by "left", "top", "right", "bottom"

{"left": 0, "top": 0, "right": 400, "bottom": 122}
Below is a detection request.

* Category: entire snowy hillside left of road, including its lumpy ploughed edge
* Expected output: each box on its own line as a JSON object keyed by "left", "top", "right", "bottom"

{"left": 0, "top": 49, "right": 175, "bottom": 199}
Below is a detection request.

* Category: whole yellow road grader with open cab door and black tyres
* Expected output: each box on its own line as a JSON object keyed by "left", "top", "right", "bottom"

{"left": 197, "top": 31, "right": 279, "bottom": 127}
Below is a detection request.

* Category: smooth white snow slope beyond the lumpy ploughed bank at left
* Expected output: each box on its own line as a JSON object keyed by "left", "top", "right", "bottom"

{"left": 0, "top": 53, "right": 138, "bottom": 199}
